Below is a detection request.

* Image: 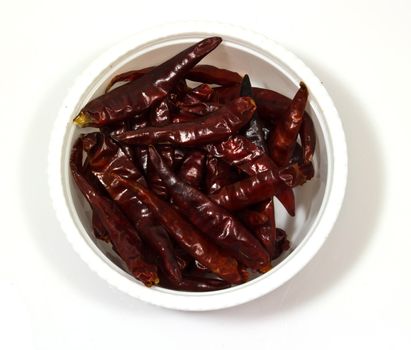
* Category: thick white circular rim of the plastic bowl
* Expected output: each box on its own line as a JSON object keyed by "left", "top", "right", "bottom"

{"left": 48, "top": 21, "right": 348, "bottom": 311}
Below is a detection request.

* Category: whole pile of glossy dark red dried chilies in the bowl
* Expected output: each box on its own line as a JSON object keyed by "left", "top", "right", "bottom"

{"left": 70, "top": 37, "right": 315, "bottom": 291}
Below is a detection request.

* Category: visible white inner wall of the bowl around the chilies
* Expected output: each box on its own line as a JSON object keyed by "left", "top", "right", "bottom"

{"left": 62, "top": 34, "right": 328, "bottom": 294}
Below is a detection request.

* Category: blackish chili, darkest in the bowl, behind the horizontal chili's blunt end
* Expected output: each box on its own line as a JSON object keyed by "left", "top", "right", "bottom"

{"left": 240, "top": 74, "right": 267, "bottom": 152}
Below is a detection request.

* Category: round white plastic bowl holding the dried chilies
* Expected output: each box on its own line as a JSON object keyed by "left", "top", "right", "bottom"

{"left": 49, "top": 22, "right": 347, "bottom": 311}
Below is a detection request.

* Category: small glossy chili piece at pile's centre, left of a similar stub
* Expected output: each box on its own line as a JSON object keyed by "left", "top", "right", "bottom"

{"left": 177, "top": 151, "right": 206, "bottom": 190}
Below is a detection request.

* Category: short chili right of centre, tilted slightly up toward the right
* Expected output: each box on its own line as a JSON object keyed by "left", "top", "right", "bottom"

{"left": 209, "top": 170, "right": 281, "bottom": 211}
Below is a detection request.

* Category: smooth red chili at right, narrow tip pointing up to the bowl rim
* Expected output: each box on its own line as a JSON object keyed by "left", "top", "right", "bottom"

{"left": 268, "top": 82, "right": 308, "bottom": 166}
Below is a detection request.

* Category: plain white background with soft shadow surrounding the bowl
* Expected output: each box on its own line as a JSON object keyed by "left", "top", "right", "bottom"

{"left": 0, "top": 0, "right": 411, "bottom": 350}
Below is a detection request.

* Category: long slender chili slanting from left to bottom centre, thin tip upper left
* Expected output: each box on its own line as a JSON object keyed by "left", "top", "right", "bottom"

{"left": 113, "top": 174, "right": 241, "bottom": 283}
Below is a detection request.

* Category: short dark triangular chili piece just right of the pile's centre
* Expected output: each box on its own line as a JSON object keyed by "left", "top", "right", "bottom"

{"left": 205, "top": 157, "right": 238, "bottom": 194}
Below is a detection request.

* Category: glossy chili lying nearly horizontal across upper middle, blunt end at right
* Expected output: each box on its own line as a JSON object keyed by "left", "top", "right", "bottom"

{"left": 115, "top": 97, "right": 255, "bottom": 147}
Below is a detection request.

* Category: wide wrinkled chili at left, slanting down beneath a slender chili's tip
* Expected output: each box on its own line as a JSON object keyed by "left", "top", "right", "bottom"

{"left": 83, "top": 133, "right": 181, "bottom": 281}
